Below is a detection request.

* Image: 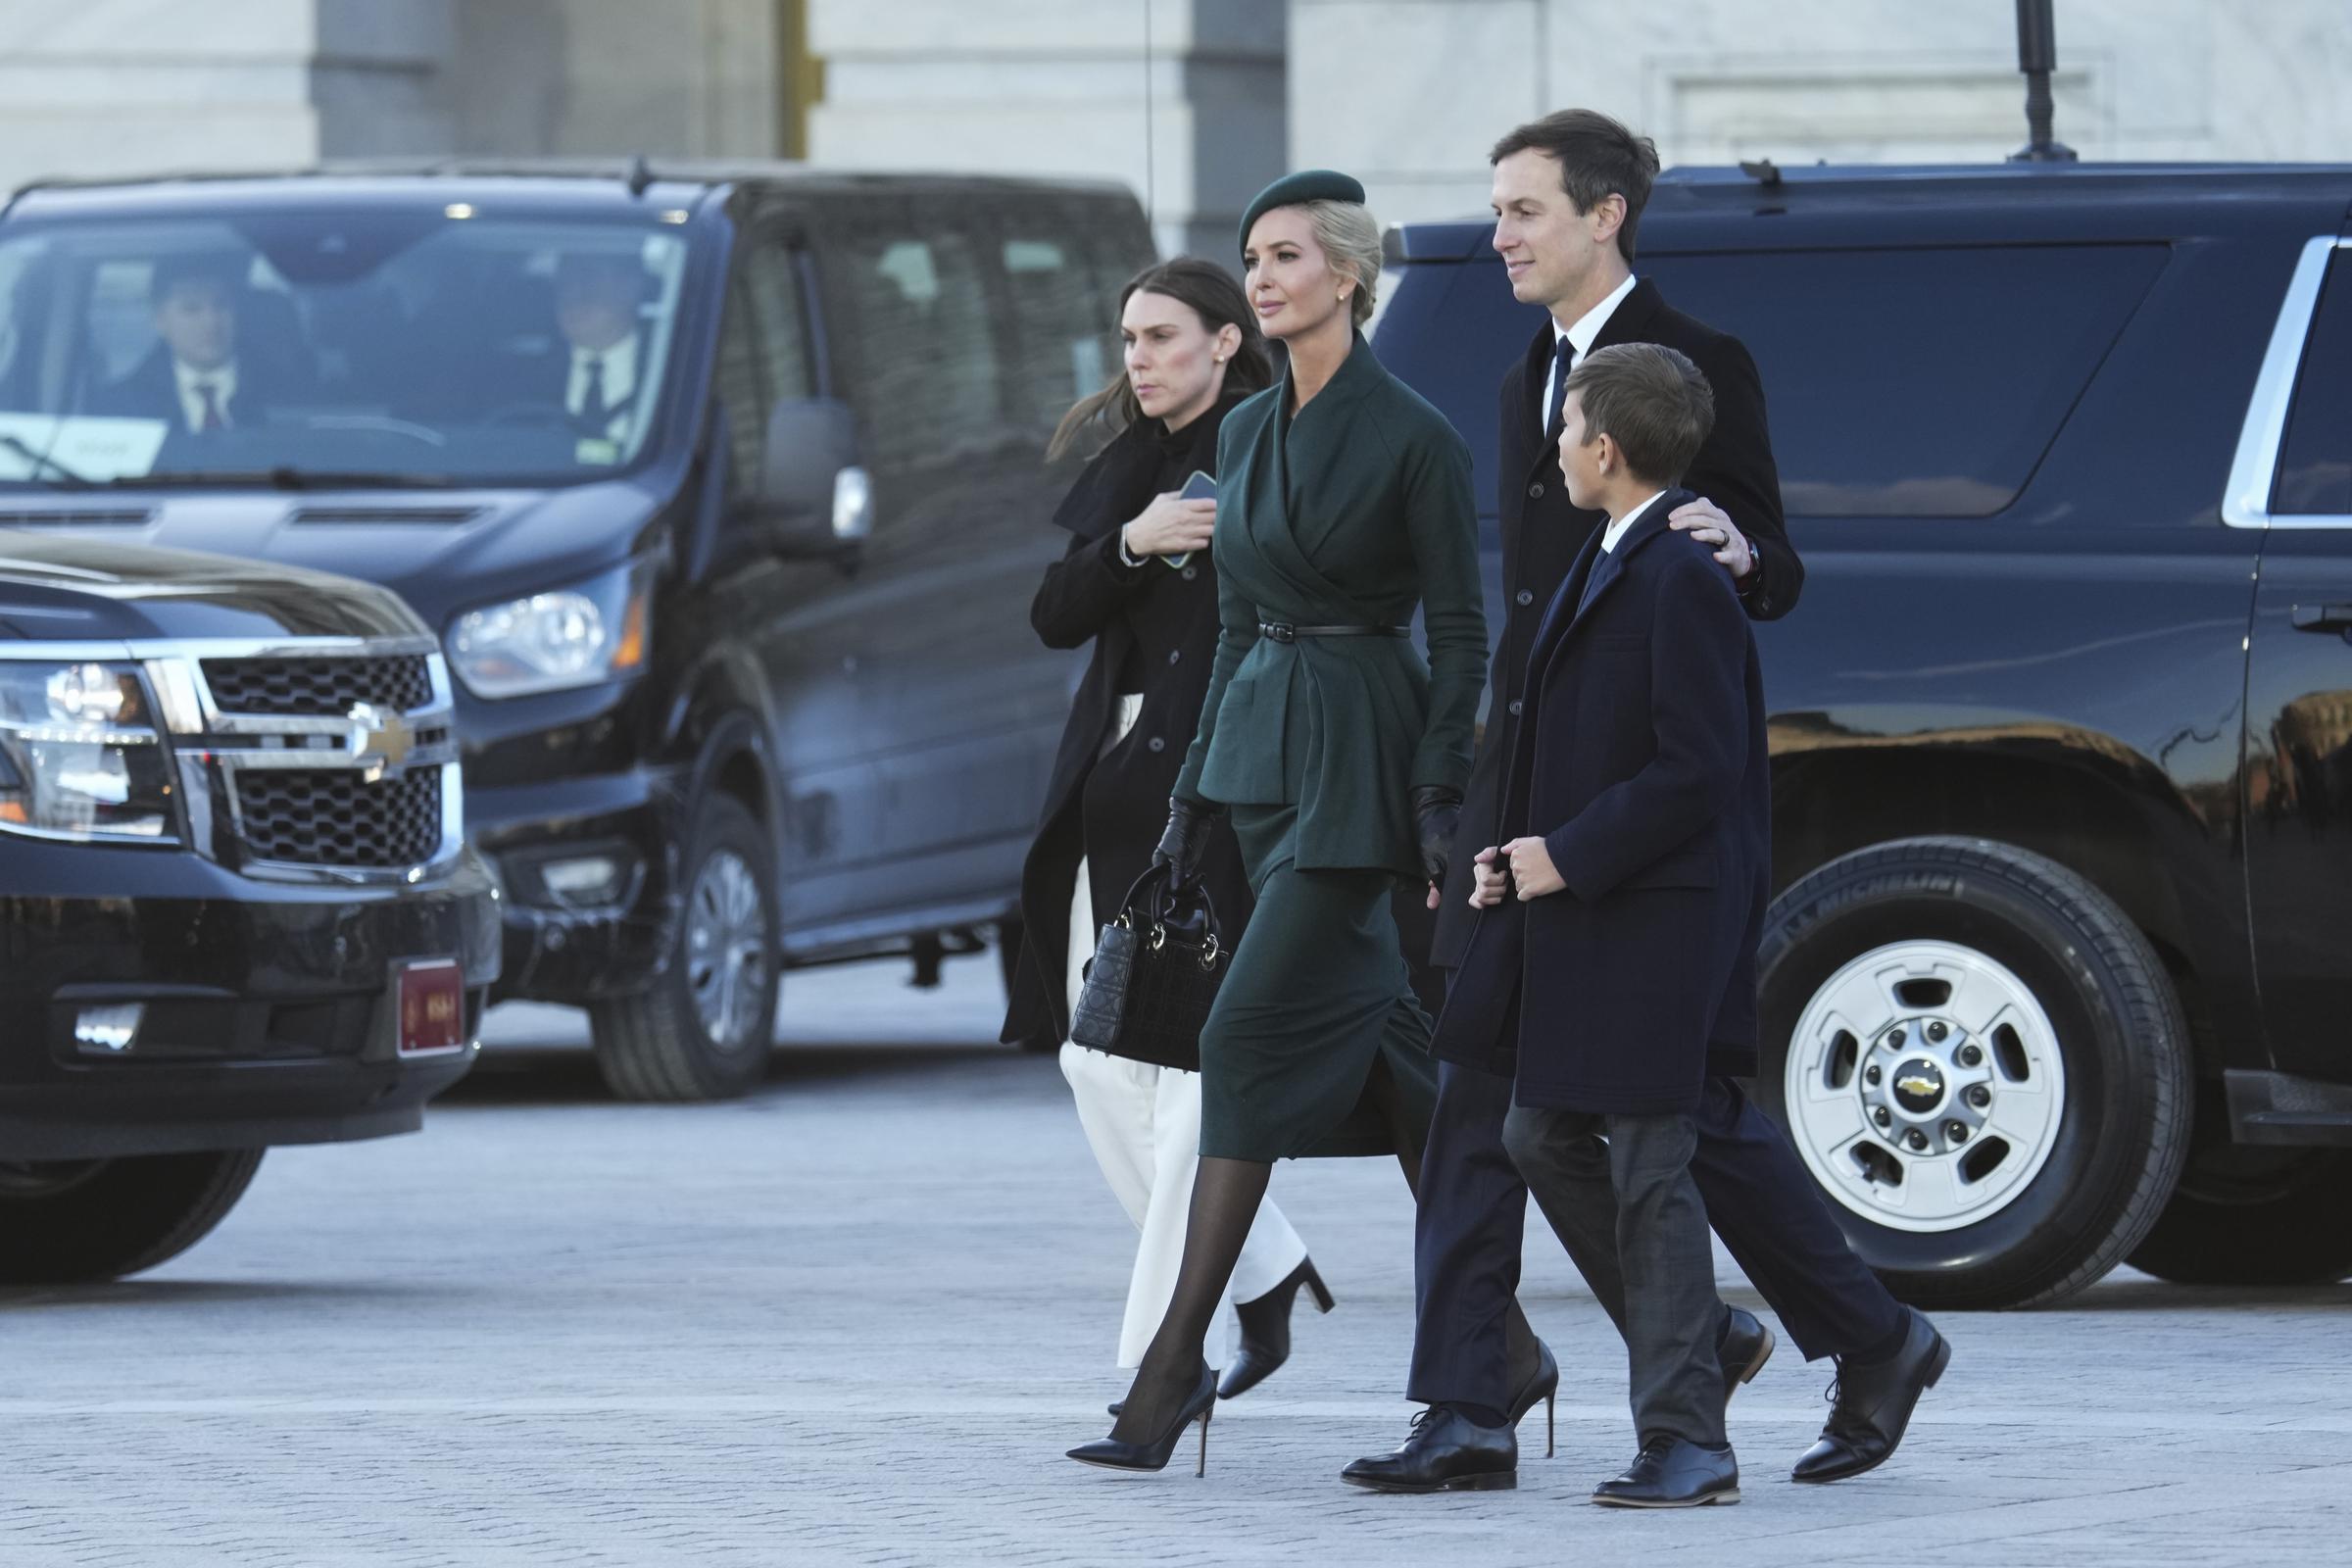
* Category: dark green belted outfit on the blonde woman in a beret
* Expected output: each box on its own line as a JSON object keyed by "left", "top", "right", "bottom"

{"left": 1176, "top": 334, "right": 1487, "bottom": 1161}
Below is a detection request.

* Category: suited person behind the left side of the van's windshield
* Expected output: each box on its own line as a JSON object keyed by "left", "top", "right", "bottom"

{"left": 92, "top": 256, "right": 272, "bottom": 435}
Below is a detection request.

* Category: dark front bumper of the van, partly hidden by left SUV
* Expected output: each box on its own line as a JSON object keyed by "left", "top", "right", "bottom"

{"left": 466, "top": 768, "right": 684, "bottom": 1004}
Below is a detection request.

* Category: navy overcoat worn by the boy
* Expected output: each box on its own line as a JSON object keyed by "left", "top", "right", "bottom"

{"left": 1435, "top": 489, "right": 1771, "bottom": 1114}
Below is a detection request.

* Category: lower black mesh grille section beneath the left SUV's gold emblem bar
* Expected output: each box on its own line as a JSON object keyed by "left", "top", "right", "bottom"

{"left": 237, "top": 766, "right": 442, "bottom": 867}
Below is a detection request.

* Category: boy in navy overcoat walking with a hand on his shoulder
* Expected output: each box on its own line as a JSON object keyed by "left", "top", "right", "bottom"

{"left": 1440, "top": 343, "right": 1771, "bottom": 1507}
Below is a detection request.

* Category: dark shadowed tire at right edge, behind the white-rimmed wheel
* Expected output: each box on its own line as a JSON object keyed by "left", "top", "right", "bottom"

{"left": 2127, "top": 1143, "right": 2352, "bottom": 1286}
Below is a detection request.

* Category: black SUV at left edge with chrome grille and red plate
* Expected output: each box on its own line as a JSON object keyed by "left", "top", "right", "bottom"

{"left": 0, "top": 534, "right": 499, "bottom": 1284}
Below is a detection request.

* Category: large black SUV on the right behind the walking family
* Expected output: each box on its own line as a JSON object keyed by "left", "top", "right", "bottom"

{"left": 1378, "top": 165, "right": 2352, "bottom": 1304}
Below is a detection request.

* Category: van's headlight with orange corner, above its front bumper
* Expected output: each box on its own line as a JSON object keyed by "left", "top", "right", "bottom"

{"left": 449, "top": 562, "right": 654, "bottom": 696}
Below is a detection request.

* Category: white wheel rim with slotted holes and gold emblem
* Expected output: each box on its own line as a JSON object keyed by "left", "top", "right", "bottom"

{"left": 1783, "top": 941, "right": 2065, "bottom": 1232}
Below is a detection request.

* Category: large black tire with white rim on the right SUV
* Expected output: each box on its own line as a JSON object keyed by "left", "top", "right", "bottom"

{"left": 1757, "top": 837, "right": 2189, "bottom": 1307}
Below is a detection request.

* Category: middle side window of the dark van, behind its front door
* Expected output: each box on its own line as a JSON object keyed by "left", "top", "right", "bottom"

{"left": 840, "top": 214, "right": 1006, "bottom": 466}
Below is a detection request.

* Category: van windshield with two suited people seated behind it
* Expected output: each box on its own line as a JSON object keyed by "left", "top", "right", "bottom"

{"left": 0, "top": 202, "right": 687, "bottom": 487}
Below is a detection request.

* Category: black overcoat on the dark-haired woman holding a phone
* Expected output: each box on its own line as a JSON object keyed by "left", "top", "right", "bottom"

{"left": 1002, "top": 395, "right": 1251, "bottom": 1072}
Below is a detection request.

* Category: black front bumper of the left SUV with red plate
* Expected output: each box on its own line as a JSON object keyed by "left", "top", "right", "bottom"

{"left": 0, "top": 842, "right": 499, "bottom": 1159}
